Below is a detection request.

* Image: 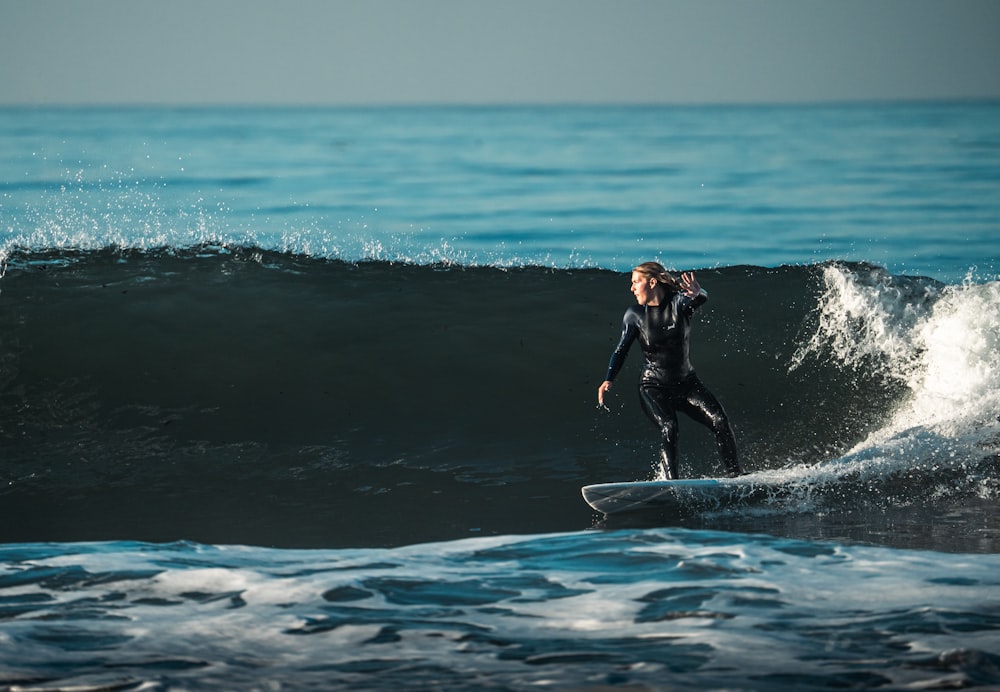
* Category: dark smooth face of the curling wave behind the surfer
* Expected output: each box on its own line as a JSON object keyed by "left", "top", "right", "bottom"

{"left": 0, "top": 248, "right": 996, "bottom": 549}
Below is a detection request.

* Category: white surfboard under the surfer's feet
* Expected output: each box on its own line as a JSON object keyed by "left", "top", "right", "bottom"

{"left": 582, "top": 476, "right": 775, "bottom": 514}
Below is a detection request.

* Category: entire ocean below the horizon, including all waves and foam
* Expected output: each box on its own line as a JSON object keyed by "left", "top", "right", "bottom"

{"left": 0, "top": 102, "right": 1000, "bottom": 692}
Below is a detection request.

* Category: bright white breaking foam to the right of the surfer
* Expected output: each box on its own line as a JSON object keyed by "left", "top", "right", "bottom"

{"left": 793, "top": 265, "right": 1000, "bottom": 486}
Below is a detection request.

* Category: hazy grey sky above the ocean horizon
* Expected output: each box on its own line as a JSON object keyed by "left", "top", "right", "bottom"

{"left": 0, "top": 0, "right": 1000, "bottom": 105}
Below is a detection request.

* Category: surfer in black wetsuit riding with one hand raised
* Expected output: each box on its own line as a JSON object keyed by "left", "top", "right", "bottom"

{"left": 597, "top": 262, "right": 743, "bottom": 480}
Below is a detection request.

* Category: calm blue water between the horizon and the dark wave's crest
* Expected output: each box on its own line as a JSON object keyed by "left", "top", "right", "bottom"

{"left": 0, "top": 103, "right": 1000, "bottom": 281}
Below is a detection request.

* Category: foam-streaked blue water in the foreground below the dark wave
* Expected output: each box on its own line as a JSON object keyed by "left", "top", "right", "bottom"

{"left": 0, "top": 529, "right": 1000, "bottom": 691}
